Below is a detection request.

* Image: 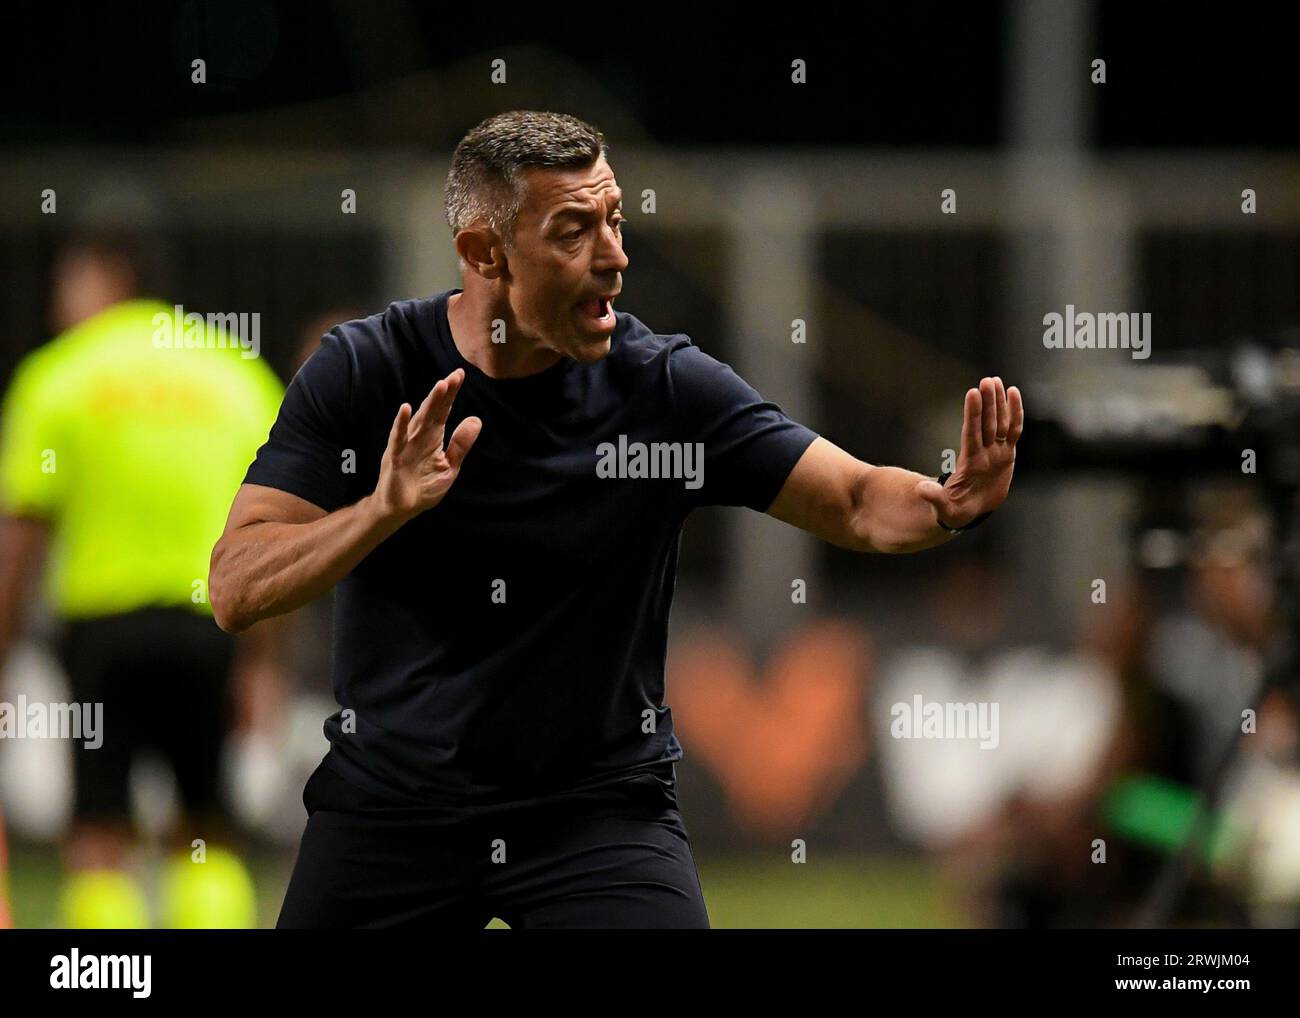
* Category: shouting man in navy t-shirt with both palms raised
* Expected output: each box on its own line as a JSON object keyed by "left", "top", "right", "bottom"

{"left": 209, "top": 112, "right": 1023, "bottom": 927}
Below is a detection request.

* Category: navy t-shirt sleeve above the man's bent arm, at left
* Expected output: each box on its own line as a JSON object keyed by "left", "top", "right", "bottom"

{"left": 243, "top": 330, "right": 355, "bottom": 512}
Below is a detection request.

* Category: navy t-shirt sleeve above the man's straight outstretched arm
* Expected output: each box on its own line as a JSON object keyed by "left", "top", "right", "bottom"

{"left": 668, "top": 343, "right": 818, "bottom": 512}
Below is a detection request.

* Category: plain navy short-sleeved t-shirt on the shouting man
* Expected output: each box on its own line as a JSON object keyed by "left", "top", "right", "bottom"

{"left": 244, "top": 290, "right": 816, "bottom": 807}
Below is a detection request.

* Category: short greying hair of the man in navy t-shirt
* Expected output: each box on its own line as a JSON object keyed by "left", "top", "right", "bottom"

{"left": 443, "top": 109, "right": 608, "bottom": 250}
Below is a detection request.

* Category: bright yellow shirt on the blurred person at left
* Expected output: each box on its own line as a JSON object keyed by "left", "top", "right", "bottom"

{"left": 0, "top": 300, "right": 283, "bottom": 618}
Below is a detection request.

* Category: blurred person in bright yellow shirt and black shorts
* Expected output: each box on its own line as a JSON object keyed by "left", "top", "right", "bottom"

{"left": 0, "top": 231, "right": 283, "bottom": 928}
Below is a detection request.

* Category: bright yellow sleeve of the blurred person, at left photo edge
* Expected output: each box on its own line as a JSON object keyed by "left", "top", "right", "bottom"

{"left": 0, "top": 348, "right": 66, "bottom": 519}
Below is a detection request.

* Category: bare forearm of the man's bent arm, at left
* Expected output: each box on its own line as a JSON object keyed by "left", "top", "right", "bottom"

{"left": 208, "top": 495, "right": 404, "bottom": 633}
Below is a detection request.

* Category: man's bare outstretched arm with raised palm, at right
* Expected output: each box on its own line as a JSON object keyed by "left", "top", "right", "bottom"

{"left": 767, "top": 377, "right": 1024, "bottom": 554}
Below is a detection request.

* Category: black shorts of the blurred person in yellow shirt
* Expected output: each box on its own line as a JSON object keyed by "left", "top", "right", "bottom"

{"left": 57, "top": 607, "right": 234, "bottom": 820}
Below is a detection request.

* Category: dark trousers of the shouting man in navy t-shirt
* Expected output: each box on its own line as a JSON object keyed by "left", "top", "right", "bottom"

{"left": 276, "top": 762, "right": 709, "bottom": 930}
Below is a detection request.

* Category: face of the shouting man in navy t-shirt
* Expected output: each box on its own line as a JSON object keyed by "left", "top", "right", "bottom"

{"left": 506, "top": 157, "right": 628, "bottom": 361}
